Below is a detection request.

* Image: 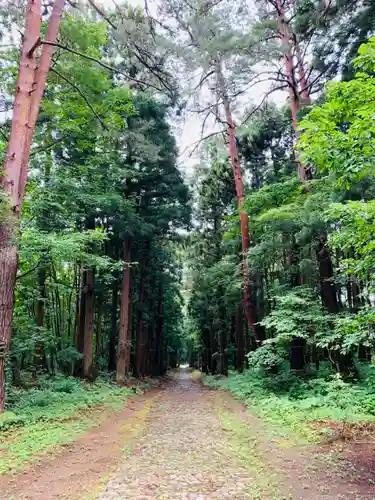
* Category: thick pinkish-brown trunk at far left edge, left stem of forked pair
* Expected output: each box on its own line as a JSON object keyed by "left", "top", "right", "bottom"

{"left": 0, "top": 0, "right": 41, "bottom": 412}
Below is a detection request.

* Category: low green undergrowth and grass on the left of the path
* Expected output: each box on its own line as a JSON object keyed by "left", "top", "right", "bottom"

{"left": 0, "top": 377, "right": 134, "bottom": 474}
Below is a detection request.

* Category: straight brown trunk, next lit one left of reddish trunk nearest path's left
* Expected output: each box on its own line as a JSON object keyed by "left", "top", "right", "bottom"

{"left": 83, "top": 268, "right": 94, "bottom": 378}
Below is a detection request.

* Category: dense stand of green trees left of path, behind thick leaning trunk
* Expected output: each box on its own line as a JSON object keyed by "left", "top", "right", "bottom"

{"left": 0, "top": 6, "right": 189, "bottom": 411}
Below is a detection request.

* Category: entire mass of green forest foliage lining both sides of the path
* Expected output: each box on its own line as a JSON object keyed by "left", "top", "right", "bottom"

{"left": 0, "top": 0, "right": 375, "bottom": 442}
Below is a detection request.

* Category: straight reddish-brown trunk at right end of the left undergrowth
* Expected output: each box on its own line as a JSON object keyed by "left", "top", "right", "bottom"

{"left": 116, "top": 239, "right": 130, "bottom": 384}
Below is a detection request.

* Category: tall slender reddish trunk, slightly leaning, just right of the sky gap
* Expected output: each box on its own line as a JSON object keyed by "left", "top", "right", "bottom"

{"left": 216, "top": 62, "right": 256, "bottom": 338}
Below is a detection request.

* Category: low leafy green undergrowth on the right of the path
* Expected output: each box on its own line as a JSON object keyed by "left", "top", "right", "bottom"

{"left": 204, "top": 366, "right": 375, "bottom": 440}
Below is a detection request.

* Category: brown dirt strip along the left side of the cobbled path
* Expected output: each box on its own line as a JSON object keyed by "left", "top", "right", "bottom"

{"left": 0, "top": 391, "right": 153, "bottom": 500}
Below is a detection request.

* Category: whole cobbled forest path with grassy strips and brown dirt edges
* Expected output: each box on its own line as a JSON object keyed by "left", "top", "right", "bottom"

{"left": 0, "top": 371, "right": 375, "bottom": 500}
